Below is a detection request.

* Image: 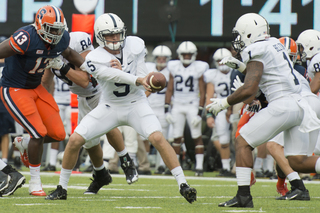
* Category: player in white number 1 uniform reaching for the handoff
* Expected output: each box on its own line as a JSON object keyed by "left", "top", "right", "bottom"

{"left": 207, "top": 13, "right": 320, "bottom": 207}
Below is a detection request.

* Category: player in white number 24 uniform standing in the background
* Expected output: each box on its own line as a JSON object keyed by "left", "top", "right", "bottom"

{"left": 165, "top": 41, "right": 209, "bottom": 176}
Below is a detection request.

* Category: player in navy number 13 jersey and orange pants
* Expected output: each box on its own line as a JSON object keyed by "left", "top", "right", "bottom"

{"left": 0, "top": 5, "right": 89, "bottom": 196}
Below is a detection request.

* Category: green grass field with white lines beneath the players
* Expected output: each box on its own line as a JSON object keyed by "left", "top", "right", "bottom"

{"left": 0, "top": 171, "right": 320, "bottom": 213}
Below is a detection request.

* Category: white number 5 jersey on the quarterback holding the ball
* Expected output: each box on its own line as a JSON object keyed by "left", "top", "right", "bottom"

{"left": 86, "top": 36, "right": 149, "bottom": 104}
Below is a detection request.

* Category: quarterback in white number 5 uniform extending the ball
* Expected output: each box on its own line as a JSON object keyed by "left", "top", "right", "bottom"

{"left": 47, "top": 13, "right": 196, "bottom": 203}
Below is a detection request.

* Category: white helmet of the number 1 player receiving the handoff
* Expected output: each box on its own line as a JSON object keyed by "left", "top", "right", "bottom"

{"left": 231, "top": 13, "right": 270, "bottom": 53}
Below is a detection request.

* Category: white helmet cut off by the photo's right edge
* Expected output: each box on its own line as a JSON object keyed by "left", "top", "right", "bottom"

{"left": 296, "top": 29, "right": 320, "bottom": 61}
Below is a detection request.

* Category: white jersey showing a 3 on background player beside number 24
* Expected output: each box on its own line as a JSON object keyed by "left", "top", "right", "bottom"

{"left": 204, "top": 69, "right": 231, "bottom": 98}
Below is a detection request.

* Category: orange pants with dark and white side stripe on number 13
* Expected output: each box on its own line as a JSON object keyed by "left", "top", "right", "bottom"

{"left": 0, "top": 85, "right": 66, "bottom": 141}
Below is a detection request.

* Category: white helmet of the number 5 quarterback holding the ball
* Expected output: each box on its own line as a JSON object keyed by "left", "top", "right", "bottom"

{"left": 94, "top": 13, "right": 127, "bottom": 50}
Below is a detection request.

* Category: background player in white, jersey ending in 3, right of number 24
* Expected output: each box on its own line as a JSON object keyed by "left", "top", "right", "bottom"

{"left": 204, "top": 48, "right": 234, "bottom": 177}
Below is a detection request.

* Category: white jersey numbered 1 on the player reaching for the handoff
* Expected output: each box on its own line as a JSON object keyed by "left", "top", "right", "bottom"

{"left": 241, "top": 38, "right": 301, "bottom": 103}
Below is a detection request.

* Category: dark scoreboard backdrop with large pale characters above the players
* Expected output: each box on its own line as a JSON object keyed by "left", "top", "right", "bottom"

{"left": 0, "top": 0, "right": 320, "bottom": 65}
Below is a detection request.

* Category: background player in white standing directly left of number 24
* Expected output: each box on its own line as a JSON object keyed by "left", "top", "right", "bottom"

{"left": 146, "top": 45, "right": 172, "bottom": 174}
